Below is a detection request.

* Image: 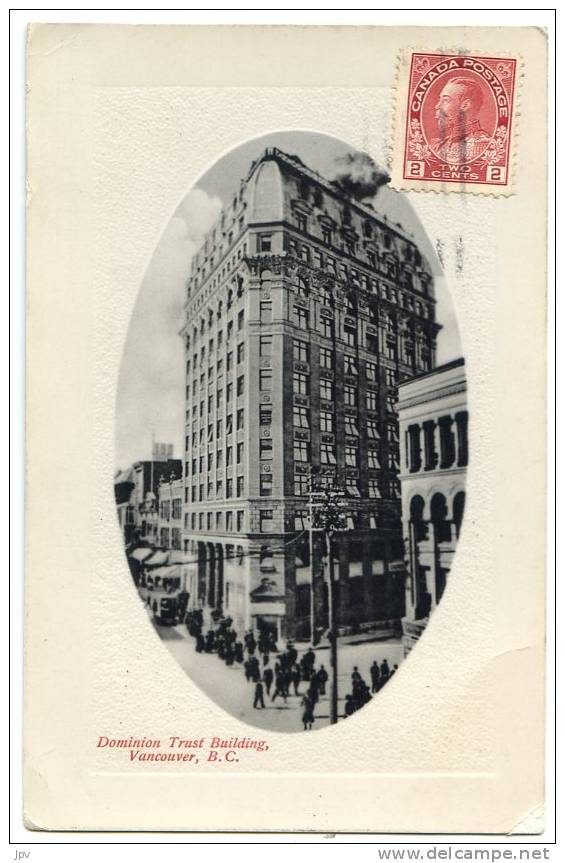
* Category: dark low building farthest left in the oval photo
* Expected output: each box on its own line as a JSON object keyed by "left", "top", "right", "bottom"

{"left": 114, "top": 458, "right": 182, "bottom": 545}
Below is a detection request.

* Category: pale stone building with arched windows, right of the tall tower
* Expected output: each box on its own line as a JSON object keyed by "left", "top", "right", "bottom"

{"left": 398, "top": 359, "right": 468, "bottom": 652}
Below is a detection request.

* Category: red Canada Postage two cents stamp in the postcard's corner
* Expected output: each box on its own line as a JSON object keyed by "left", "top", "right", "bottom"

{"left": 403, "top": 54, "right": 516, "bottom": 191}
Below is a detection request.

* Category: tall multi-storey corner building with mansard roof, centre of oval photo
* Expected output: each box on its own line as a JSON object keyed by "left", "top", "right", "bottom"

{"left": 182, "top": 149, "right": 439, "bottom": 638}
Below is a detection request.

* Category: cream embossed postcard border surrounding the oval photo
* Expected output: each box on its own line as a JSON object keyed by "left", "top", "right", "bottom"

{"left": 24, "top": 25, "right": 546, "bottom": 833}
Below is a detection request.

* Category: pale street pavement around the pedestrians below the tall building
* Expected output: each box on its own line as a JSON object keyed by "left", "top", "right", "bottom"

{"left": 156, "top": 625, "right": 403, "bottom": 732}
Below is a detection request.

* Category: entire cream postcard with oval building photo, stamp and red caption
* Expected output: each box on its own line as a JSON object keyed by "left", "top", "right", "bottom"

{"left": 23, "top": 25, "right": 547, "bottom": 834}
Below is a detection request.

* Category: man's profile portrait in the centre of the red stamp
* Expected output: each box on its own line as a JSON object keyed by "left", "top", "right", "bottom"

{"left": 431, "top": 76, "right": 491, "bottom": 165}
